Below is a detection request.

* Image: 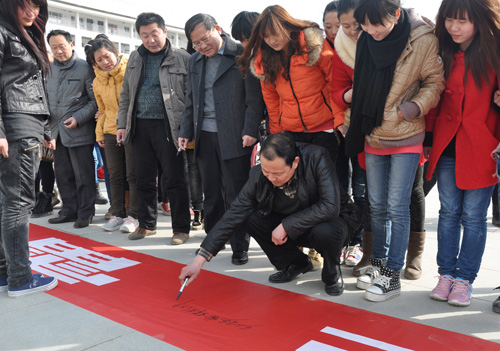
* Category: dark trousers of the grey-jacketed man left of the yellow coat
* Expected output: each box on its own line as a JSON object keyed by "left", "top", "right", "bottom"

{"left": 54, "top": 138, "right": 95, "bottom": 218}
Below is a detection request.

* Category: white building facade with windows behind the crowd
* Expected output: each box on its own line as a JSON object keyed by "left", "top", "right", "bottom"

{"left": 46, "top": 0, "right": 187, "bottom": 58}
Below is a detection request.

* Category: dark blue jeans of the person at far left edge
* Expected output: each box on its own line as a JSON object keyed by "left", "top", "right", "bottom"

{"left": 0, "top": 138, "right": 41, "bottom": 289}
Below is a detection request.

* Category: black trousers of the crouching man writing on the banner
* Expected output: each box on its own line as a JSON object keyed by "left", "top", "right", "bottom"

{"left": 246, "top": 212, "right": 349, "bottom": 285}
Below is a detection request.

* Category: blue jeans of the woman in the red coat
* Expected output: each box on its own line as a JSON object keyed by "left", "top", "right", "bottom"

{"left": 436, "top": 156, "right": 495, "bottom": 283}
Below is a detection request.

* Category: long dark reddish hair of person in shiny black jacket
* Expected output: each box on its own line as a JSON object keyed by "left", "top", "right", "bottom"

{"left": 0, "top": 0, "right": 49, "bottom": 73}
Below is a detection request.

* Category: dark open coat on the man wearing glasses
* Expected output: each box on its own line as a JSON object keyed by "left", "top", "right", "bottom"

{"left": 179, "top": 34, "right": 264, "bottom": 160}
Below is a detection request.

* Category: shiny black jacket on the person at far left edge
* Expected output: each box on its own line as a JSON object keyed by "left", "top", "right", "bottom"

{"left": 0, "top": 15, "right": 49, "bottom": 138}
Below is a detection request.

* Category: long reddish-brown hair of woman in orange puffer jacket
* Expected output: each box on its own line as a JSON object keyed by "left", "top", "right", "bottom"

{"left": 238, "top": 5, "right": 319, "bottom": 83}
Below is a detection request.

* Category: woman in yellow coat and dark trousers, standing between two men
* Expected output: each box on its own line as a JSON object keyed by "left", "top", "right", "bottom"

{"left": 89, "top": 39, "right": 139, "bottom": 233}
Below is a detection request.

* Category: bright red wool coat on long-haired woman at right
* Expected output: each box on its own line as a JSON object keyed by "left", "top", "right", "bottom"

{"left": 426, "top": 52, "right": 500, "bottom": 190}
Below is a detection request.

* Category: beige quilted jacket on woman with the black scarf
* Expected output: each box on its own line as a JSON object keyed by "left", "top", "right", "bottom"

{"left": 366, "top": 9, "right": 445, "bottom": 148}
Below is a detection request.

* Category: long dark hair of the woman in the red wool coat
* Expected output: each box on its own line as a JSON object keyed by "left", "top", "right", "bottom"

{"left": 436, "top": 0, "right": 500, "bottom": 89}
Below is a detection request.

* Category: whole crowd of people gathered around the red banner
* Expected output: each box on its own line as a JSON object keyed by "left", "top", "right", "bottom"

{"left": 0, "top": 0, "right": 500, "bottom": 313}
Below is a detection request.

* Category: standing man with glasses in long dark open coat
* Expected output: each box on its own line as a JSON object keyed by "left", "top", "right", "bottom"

{"left": 179, "top": 14, "right": 264, "bottom": 264}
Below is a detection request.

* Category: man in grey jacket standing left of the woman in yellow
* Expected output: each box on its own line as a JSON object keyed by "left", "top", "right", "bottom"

{"left": 47, "top": 30, "right": 97, "bottom": 228}
